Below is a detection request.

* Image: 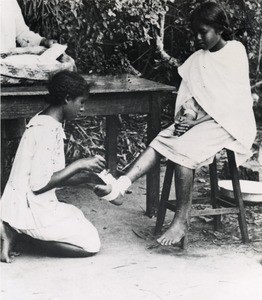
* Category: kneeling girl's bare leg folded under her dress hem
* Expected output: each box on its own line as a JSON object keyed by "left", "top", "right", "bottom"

{"left": 34, "top": 240, "right": 96, "bottom": 257}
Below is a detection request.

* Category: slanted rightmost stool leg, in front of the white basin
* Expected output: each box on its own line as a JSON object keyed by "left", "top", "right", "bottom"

{"left": 227, "top": 149, "right": 249, "bottom": 243}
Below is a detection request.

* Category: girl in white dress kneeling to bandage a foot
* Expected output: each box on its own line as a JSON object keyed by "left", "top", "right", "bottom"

{"left": 1, "top": 71, "right": 105, "bottom": 262}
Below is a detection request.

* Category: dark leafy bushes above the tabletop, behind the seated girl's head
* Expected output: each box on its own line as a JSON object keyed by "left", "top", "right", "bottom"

{"left": 18, "top": 0, "right": 262, "bottom": 83}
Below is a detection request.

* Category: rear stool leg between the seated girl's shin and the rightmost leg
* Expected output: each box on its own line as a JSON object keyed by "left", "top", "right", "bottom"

{"left": 209, "top": 157, "right": 222, "bottom": 231}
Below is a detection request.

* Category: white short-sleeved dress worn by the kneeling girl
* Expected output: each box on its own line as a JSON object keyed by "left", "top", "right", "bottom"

{"left": 1, "top": 115, "right": 100, "bottom": 252}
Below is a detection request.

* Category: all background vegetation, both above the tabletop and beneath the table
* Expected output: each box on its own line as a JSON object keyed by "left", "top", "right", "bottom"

{"left": 11, "top": 0, "right": 262, "bottom": 169}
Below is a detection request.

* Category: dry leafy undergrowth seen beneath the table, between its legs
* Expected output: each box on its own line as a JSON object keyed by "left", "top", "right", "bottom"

{"left": 65, "top": 115, "right": 146, "bottom": 172}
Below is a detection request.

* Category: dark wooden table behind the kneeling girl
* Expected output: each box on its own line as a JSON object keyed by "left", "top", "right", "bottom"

{"left": 1, "top": 75, "right": 175, "bottom": 217}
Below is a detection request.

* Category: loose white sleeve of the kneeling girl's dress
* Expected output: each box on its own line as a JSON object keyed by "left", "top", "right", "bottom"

{"left": 29, "top": 126, "right": 57, "bottom": 191}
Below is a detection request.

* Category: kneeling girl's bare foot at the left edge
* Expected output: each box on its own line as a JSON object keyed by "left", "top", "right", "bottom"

{"left": 0, "top": 221, "right": 17, "bottom": 263}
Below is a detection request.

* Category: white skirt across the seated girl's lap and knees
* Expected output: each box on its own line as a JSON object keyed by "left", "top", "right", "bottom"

{"left": 149, "top": 120, "right": 251, "bottom": 169}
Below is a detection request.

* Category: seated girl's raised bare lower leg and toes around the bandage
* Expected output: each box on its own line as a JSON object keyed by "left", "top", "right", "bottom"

{"left": 94, "top": 147, "right": 161, "bottom": 205}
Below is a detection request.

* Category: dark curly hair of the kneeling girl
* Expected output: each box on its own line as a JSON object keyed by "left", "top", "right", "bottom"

{"left": 46, "top": 70, "right": 90, "bottom": 105}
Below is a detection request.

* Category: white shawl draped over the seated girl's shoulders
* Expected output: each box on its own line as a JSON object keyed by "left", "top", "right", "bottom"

{"left": 176, "top": 41, "right": 256, "bottom": 150}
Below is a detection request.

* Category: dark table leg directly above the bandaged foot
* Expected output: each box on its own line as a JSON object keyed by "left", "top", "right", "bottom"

{"left": 105, "top": 116, "right": 118, "bottom": 176}
